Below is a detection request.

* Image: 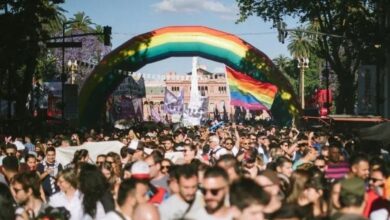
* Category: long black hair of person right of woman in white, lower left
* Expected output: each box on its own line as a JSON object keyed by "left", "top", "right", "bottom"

{"left": 79, "top": 163, "right": 109, "bottom": 218}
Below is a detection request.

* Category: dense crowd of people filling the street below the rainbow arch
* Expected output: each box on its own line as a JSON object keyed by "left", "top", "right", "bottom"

{"left": 0, "top": 123, "right": 390, "bottom": 220}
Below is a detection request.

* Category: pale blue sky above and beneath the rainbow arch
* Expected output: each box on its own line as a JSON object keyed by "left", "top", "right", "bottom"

{"left": 62, "top": 0, "right": 297, "bottom": 74}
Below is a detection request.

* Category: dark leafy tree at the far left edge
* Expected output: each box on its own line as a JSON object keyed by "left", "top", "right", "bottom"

{"left": 0, "top": 0, "right": 64, "bottom": 117}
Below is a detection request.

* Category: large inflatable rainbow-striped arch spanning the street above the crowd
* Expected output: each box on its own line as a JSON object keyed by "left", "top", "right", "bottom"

{"left": 79, "top": 26, "right": 300, "bottom": 127}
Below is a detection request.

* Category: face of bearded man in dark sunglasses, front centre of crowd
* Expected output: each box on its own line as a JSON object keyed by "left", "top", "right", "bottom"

{"left": 201, "top": 177, "right": 228, "bottom": 214}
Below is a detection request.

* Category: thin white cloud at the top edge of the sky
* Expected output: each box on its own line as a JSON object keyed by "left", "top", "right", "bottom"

{"left": 152, "top": 0, "right": 238, "bottom": 20}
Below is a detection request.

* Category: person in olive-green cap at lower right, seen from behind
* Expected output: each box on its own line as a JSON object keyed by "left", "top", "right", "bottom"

{"left": 330, "top": 176, "right": 366, "bottom": 220}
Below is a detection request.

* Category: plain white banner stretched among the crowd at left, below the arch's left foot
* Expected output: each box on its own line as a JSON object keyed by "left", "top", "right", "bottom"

{"left": 56, "top": 141, "right": 124, "bottom": 166}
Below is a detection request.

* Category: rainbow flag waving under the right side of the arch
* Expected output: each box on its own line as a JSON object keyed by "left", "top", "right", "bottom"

{"left": 226, "top": 67, "right": 278, "bottom": 110}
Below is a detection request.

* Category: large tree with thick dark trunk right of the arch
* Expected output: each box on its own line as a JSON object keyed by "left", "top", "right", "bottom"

{"left": 237, "top": 0, "right": 382, "bottom": 114}
